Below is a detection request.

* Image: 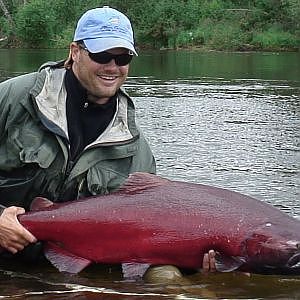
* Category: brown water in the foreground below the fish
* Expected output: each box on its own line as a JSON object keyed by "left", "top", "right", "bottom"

{"left": 0, "top": 265, "right": 300, "bottom": 299}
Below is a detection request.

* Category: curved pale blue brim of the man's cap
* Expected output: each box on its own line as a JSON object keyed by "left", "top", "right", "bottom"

{"left": 83, "top": 38, "right": 138, "bottom": 56}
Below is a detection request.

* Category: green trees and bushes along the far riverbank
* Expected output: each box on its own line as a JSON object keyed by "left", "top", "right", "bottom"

{"left": 0, "top": 0, "right": 300, "bottom": 51}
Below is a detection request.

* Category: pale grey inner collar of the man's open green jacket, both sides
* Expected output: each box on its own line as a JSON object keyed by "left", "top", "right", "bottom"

{"left": 31, "top": 66, "right": 139, "bottom": 147}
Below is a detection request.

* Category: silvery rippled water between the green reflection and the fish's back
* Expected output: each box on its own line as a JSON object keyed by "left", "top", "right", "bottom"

{"left": 126, "top": 77, "right": 300, "bottom": 216}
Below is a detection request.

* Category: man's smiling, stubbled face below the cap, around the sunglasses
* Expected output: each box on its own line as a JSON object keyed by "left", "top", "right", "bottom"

{"left": 71, "top": 43, "right": 129, "bottom": 104}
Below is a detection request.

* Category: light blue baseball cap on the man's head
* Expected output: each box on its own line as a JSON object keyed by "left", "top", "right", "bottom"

{"left": 73, "top": 6, "right": 138, "bottom": 55}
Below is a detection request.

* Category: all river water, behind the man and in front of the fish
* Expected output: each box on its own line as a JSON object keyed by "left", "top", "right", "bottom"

{"left": 0, "top": 50, "right": 300, "bottom": 299}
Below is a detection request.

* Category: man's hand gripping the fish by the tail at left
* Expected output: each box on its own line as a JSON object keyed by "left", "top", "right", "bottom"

{"left": 0, "top": 206, "right": 37, "bottom": 254}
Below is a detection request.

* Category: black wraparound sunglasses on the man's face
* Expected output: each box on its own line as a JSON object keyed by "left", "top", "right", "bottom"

{"left": 78, "top": 44, "right": 133, "bottom": 67}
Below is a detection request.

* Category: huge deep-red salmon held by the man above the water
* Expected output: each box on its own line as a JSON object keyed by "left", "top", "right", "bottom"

{"left": 19, "top": 173, "right": 300, "bottom": 274}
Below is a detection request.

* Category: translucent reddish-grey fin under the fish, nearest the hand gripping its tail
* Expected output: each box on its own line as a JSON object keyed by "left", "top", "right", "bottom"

{"left": 44, "top": 242, "right": 91, "bottom": 274}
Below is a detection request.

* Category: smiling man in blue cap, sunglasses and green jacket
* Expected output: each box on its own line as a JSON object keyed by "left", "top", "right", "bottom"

{"left": 0, "top": 7, "right": 214, "bottom": 276}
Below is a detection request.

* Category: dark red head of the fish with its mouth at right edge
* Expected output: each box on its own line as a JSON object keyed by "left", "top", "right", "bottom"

{"left": 246, "top": 233, "right": 300, "bottom": 275}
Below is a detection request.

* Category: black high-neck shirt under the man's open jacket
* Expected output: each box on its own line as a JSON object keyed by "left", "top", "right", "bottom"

{"left": 65, "top": 69, "right": 117, "bottom": 160}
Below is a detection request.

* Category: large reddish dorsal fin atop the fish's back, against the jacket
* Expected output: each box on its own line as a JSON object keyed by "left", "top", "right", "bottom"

{"left": 117, "top": 172, "right": 170, "bottom": 194}
